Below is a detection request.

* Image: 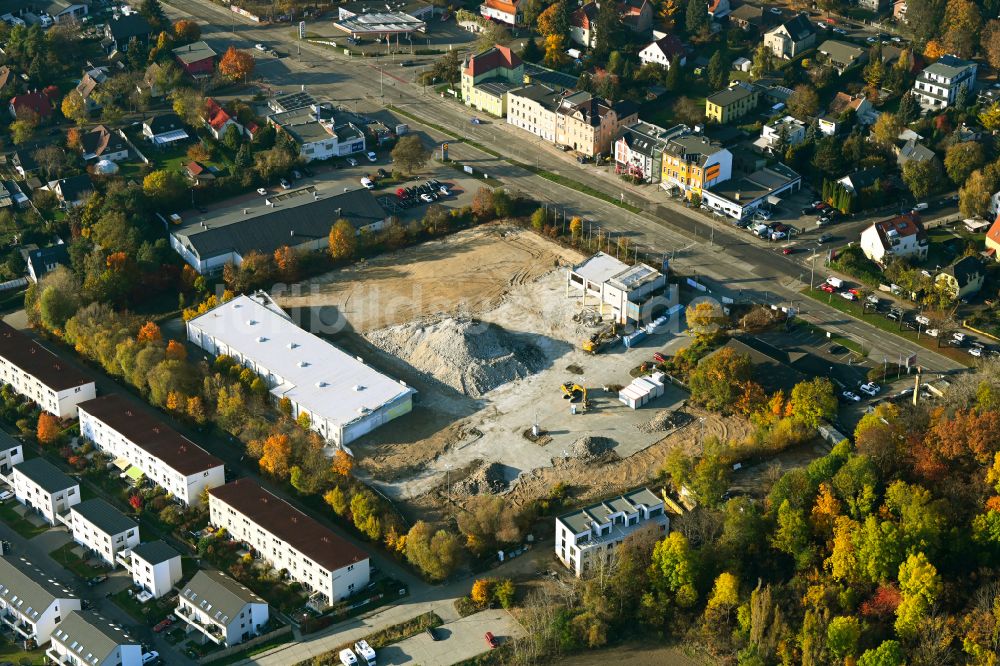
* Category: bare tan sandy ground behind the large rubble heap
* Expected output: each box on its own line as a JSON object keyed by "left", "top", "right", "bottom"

{"left": 280, "top": 223, "right": 583, "bottom": 334}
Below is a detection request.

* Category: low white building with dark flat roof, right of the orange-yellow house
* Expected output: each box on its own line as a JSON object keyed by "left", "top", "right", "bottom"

{"left": 701, "top": 162, "right": 802, "bottom": 220}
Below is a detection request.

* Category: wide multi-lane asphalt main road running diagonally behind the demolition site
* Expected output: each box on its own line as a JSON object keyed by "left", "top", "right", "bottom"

{"left": 158, "top": 0, "right": 963, "bottom": 373}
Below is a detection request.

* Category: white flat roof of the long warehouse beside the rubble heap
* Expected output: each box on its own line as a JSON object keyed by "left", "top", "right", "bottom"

{"left": 188, "top": 293, "right": 415, "bottom": 427}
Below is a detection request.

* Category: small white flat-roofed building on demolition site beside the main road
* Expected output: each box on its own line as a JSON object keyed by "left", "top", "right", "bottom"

{"left": 566, "top": 252, "right": 676, "bottom": 324}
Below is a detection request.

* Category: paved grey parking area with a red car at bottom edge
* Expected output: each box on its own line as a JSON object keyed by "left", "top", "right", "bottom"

{"left": 378, "top": 609, "right": 523, "bottom": 666}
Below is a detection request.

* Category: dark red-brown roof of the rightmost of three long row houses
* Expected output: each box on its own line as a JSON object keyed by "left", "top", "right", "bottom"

{"left": 208, "top": 478, "right": 368, "bottom": 572}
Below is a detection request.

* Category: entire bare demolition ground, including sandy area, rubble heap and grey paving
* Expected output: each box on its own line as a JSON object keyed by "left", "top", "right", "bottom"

{"left": 280, "top": 224, "right": 746, "bottom": 515}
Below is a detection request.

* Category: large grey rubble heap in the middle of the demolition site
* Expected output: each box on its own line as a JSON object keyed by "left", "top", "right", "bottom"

{"left": 366, "top": 317, "right": 545, "bottom": 398}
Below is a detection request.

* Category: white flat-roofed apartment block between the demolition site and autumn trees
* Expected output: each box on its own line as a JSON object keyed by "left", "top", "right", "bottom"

{"left": 555, "top": 488, "right": 670, "bottom": 576}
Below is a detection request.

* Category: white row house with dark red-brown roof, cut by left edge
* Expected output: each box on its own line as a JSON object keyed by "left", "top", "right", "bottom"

{"left": 0, "top": 321, "right": 96, "bottom": 419}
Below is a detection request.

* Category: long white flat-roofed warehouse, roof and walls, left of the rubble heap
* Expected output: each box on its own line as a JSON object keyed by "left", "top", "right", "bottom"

{"left": 187, "top": 293, "right": 415, "bottom": 446}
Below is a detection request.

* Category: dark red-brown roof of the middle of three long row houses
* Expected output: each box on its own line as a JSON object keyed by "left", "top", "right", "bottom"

{"left": 77, "top": 393, "right": 222, "bottom": 476}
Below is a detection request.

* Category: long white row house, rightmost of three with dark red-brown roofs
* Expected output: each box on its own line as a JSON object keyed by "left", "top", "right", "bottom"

{"left": 208, "top": 478, "right": 370, "bottom": 605}
